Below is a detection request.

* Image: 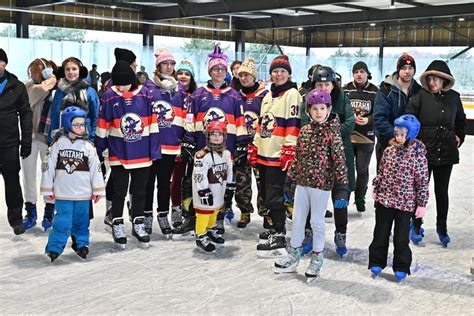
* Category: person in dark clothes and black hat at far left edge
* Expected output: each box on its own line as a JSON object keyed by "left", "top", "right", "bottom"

{"left": 0, "top": 48, "right": 32, "bottom": 235}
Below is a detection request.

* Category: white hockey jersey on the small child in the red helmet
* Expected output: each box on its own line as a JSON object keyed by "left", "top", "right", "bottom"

{"left": 193, "top": 147, "right": 233, "bottom": 211}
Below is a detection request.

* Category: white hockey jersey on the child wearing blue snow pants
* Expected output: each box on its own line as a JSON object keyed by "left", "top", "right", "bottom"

{"left": 40, "top": 136, "right": 105, "bottom": 200}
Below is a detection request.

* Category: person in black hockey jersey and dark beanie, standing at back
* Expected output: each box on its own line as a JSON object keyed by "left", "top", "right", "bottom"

{"left": 343, "top": 61, "right": 379, "bottom": 212}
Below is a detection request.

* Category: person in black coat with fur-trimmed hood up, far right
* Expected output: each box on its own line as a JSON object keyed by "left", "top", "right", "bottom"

{"left": 406, "top": 60, "right": 466, "bottom": 247}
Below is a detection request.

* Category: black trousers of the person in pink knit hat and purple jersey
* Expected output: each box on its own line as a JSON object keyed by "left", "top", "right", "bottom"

{"left": 144, "top": 155, "right": 176, "bottom": 212}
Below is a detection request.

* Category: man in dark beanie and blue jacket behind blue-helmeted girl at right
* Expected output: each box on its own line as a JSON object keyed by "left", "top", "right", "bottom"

{"left": 374, "top": 53, "right": 420, "bottom": 166}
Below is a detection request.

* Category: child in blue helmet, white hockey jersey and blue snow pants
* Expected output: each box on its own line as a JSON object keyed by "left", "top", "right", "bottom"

{"left": 41, "top": 106, "right": 105, "bottom": 262}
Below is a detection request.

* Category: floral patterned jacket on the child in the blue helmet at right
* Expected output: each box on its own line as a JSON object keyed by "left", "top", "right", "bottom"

{"left": 373, "top": 139, "right": 429, "bottom": 212}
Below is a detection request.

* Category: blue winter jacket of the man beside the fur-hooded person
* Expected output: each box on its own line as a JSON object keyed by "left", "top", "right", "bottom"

{"left": 374, "top": 72, "right": 421, "bottom": 146}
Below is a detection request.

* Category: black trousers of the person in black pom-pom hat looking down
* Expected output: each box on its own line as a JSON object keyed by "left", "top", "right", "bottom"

{"left": 111, "top": 166, "right": 148, "bottom": 218}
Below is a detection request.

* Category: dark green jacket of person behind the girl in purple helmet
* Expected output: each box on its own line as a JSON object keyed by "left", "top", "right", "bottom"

{"left": 301, "top": 88, "right": 355, "bottom": 191}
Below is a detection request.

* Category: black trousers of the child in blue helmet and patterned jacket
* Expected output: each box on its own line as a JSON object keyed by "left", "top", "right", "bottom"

{"left": 369, "top": 203, "right": 412, "bottom": 274}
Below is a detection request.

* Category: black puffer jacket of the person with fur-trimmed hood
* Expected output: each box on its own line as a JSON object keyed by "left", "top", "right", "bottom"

{"left": 406, "top": 89, "right": 466, "bottom": 166}
